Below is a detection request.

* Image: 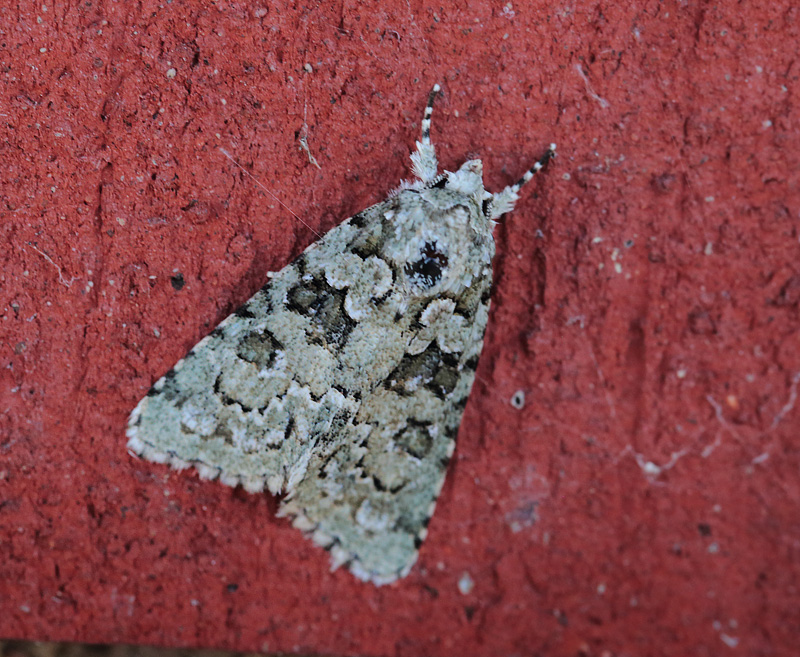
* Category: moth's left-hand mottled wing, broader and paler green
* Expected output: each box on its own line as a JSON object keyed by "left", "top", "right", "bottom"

{"left": 127, "top": 204, "right": 394, "bottom": 493}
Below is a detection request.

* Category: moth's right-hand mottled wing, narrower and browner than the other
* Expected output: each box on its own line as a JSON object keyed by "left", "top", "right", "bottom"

{"left": 280, "top": 272, "right": 491, "bottom": 584}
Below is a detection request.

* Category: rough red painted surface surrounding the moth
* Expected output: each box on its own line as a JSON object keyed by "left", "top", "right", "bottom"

{"left": 0, "top": 0, "right": 800, "bottom": 657}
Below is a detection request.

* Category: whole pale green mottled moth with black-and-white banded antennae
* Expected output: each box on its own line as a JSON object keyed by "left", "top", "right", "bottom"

{"left": 127, "top": 85, "right": 555, "bottom": 585}
